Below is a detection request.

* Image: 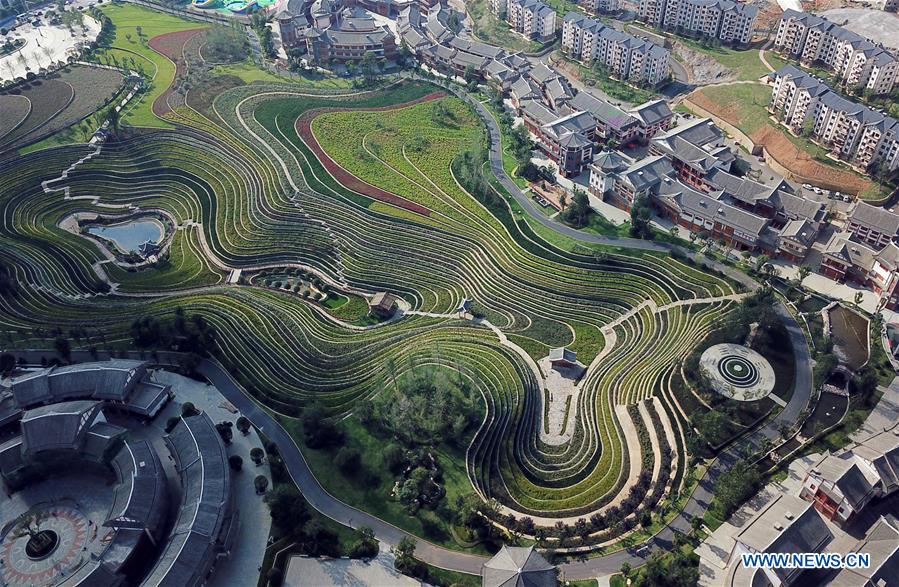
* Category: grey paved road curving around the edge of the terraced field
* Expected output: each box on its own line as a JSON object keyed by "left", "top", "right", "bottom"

{"left": 5, "top": 81, "right": 812, "bottom": 580}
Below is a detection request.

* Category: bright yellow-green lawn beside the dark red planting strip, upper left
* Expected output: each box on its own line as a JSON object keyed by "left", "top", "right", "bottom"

{"left": 97, "top": 4, "right": 208, "bottom": 128}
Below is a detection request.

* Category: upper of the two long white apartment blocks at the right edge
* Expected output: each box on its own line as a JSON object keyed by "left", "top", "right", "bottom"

{"left": 774, "top": 10, "right": 899, "bottom": 94}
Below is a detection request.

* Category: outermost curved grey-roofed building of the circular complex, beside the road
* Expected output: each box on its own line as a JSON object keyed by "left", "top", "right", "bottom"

{"left": 143, "top": 414, "right": 237, "bottom": 587}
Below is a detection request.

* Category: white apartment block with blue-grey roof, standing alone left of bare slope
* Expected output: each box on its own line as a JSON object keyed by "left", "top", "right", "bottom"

{"left": 562, "top": 12, "right": 671, "bottom": 86}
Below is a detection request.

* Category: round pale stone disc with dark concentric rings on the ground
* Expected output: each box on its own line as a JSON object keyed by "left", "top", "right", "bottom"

{"left": 699, "top": 344, "right": 774, "bottom": 402}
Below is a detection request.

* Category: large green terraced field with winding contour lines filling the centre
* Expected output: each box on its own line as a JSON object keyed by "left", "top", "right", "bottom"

{"left": 0, "top": 59, "right": 742, "bottom": 541}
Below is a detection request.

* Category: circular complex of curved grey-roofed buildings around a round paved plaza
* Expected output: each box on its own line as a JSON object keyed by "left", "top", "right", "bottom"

{"left": 0, "top": 360, "right": 238, "bottom": 587}
